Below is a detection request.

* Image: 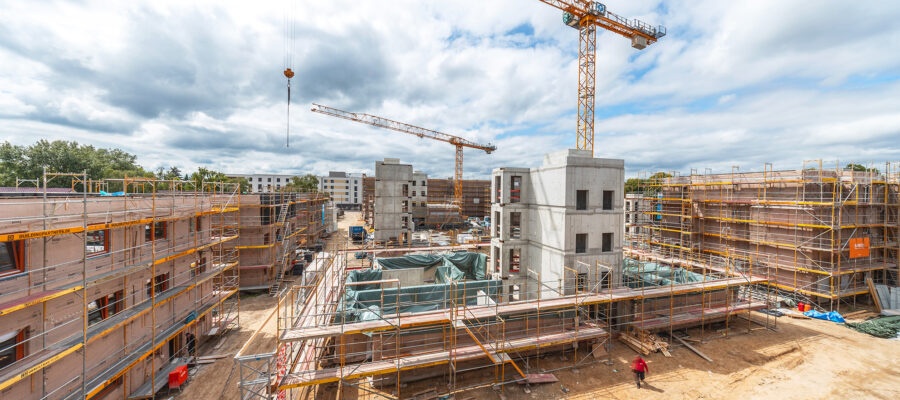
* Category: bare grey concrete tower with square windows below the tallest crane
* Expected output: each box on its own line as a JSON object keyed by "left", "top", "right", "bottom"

{"left": 491, "top": 149, "right": 625, "bottom": 296}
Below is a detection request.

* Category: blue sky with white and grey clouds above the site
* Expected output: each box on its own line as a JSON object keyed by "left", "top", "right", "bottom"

{"left": 0, "top": 0, "right": 900, "bottom": 177}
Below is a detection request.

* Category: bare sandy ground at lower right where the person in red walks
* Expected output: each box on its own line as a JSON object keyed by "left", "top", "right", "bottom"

{"left": 450, "top": 314, "right": 900, "bottom": 399}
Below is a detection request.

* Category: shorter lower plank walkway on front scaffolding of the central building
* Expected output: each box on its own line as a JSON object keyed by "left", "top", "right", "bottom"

{"left": 278, "top": 327, "right": 607, "bottom": 390}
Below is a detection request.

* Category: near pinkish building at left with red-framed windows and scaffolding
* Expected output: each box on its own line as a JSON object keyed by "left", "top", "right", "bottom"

{"left": 0, "top": 173, "right": 240, "bottom": 399}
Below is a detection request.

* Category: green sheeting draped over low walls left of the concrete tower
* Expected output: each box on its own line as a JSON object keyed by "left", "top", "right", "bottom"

{"left": 335, "top": 253, "right": 500, "bottom": 323}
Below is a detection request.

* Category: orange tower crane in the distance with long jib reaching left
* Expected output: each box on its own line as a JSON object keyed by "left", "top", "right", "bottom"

{"left": 312, "top": 103, "right": 497, "bottom": 209}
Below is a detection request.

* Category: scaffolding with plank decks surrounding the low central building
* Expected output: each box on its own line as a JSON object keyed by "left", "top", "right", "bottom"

{"left": 235, "top": 241, "right": 773, "bottom": 400}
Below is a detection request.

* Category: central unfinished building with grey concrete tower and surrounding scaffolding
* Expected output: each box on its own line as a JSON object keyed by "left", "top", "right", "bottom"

{"left": 235, "top": 150, "right": 767, "bottom": 399}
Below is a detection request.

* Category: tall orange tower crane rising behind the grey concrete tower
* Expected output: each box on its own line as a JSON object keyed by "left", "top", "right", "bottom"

{"left": 539, "top": 0, "right": 666, "bottom": 155}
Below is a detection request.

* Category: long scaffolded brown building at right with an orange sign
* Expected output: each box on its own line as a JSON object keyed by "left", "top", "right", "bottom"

{"left": 629, "top": 161, "right": 900, "bottom": 311}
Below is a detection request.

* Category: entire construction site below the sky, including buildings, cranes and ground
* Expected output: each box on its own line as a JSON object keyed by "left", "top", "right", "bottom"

{"left": 0, "top": 0, "right": 900, "bottom": 400}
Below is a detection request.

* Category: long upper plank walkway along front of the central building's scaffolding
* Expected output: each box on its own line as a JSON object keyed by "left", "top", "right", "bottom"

{"left": 280, "top": 277, "right": 765, "bottom": 342}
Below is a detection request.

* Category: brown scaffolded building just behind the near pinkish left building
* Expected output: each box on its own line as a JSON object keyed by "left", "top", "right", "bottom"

{"left": 237, "top": 191, "right": 334, "bottom": 294}
